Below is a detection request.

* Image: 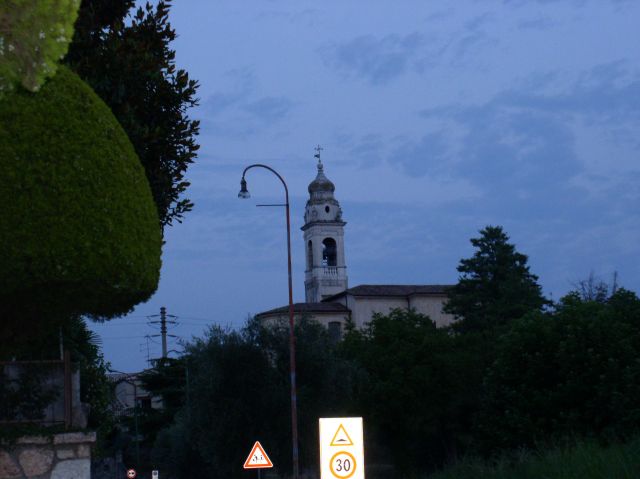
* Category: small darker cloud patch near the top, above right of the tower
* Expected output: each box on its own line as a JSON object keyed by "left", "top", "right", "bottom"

{"left": 321, "top": 33, "right": 423, "bottom": 85}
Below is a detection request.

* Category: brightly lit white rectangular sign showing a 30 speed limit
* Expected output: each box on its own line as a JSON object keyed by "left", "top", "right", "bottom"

{"left": 320, "top": 417, "right": 364, "bottom": 479}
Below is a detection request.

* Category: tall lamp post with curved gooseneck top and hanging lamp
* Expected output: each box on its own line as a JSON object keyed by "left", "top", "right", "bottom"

{"left": 238, "top": 163, "right": 299, "bottom": 479}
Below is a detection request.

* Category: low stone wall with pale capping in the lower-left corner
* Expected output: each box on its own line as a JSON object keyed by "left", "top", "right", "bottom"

{"left": 0, "top": 432, "right": 96, "bottom": 479}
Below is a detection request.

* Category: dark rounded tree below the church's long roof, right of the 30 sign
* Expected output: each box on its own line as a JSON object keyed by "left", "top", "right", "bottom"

{"left": 342, "top": 310, "right": 480, "bottom": 473}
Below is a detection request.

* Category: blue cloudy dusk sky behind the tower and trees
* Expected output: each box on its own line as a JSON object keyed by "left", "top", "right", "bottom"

{"left": 92, "top": 0, "right": 640, "bottom": 372}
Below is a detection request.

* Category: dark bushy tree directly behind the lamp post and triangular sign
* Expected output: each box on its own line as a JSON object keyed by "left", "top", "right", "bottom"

{"left": 153, "top": 318, "right": 356, "bottom": 478}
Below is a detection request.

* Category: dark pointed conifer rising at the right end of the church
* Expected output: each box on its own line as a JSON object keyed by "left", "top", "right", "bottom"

{"left": 444, "top": 226, "right": 548, "bottom": 332}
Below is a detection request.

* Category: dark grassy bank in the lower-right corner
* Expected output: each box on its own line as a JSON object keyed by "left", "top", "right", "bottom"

{"left": 425, "top": 436, "right": 640, "bottom": 479}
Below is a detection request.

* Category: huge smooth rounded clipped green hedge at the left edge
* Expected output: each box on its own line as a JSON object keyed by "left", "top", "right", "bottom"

{"left": 0, "top": 67, "right": 162, "bottom": 326}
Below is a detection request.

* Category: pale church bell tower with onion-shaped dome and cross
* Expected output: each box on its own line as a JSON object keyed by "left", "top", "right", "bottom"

{"left": 302, "top": 146, "right": 347, "bottom": 303}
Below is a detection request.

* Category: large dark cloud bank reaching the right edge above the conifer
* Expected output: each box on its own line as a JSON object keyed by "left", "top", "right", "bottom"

{"left": 372, "top": 62, "right": 640, "bottom": 222}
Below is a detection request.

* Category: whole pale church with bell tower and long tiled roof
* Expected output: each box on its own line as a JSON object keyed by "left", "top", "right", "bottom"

{"left": 256, "top": 155, "right": 453, "bottom": 339}
